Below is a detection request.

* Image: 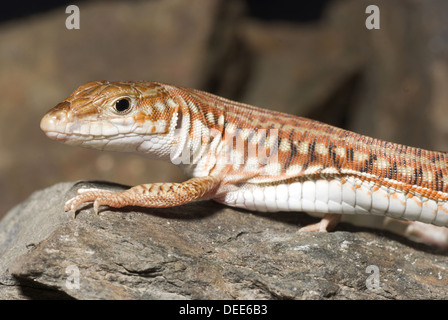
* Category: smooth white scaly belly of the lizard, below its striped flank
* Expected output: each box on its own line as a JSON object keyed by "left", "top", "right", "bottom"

{"left": 215, "top": 177, "right": 448, "bottom": 226}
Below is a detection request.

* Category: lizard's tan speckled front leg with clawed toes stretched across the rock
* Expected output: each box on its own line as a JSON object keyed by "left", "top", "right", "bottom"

{"left": 64, "top": 176, "right": 221, "bottom": 215}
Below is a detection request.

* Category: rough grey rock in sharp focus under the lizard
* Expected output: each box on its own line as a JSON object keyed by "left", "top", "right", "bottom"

{"left": 0, "top": 182, "right": 448, "bottom": 299}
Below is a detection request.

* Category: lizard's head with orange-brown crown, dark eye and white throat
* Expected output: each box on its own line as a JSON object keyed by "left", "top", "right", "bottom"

{"left": 40, "top": 81, "right": 181, "bottom": 157}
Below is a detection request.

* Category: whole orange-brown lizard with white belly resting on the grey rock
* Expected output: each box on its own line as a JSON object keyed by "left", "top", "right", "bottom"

{"left": 40, "top": 80, "right": 448, "bottom": 248}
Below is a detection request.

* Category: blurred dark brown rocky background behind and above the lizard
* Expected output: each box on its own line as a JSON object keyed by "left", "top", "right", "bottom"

{"left": 0, "top": 0, "right": 448, "bottom": 218}
